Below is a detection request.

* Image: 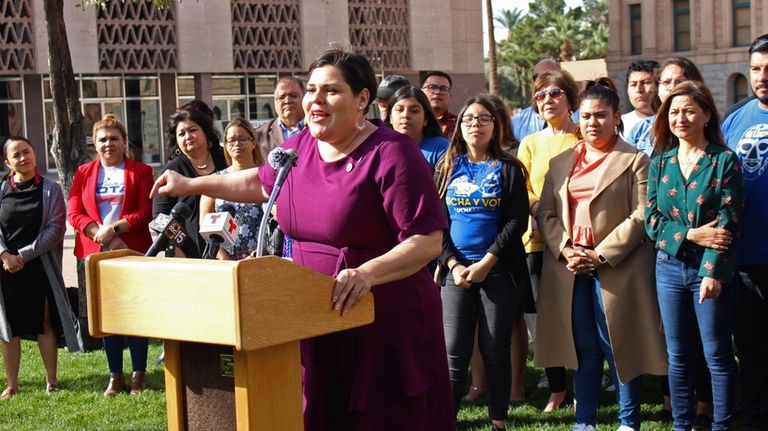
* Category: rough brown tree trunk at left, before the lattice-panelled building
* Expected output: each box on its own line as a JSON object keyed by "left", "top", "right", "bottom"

{"left": 43, "top": 0, "right": 88, "bottom": 196}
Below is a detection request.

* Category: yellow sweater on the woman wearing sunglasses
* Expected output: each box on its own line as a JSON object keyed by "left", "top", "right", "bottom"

{"left": 517, "top": 130, "right": 579, "bottom": 253}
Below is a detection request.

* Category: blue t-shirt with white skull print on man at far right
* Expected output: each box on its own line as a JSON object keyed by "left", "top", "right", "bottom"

{"left": 723, "top": 99, "right": 768, "bottom": 265}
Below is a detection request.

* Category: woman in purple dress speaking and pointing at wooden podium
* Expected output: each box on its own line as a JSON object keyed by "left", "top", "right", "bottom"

{"left": 153, "top": 47, "right": 456, "bottom": 430}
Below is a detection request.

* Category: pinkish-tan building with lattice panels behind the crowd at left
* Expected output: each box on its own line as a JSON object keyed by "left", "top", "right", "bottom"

{"left": 0, "top": 0, "right": 485, "bottom": 172}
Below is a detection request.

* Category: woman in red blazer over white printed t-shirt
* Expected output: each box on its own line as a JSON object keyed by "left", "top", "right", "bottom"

{"left": 67, "top": 114, "right": 152, "bottom": 397}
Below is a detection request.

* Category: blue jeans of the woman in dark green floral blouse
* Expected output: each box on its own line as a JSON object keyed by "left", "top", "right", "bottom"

{"left": 656, "top": 251, "right": 736, "bottom": 431}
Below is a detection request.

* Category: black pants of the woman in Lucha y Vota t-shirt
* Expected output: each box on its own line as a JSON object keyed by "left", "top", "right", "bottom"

{"left": 440, "top": 266, "right": 521, "bottom": 420}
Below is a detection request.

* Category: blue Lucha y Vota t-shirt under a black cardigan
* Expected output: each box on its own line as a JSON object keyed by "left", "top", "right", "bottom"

{"left": 445, "top": 155, "right": 503, "bottom": 260}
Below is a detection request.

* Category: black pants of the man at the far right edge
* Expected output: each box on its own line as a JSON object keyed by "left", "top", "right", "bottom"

{"left": 733, "top": 264, "right": 768, "bottom": 430}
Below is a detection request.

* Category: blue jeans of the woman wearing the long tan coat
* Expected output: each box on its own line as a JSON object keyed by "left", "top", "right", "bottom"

{"left": 572, "top": 275, "right": 643, "bottom": 429}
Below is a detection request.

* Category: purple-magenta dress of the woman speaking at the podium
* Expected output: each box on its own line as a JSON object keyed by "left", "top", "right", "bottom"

{"left": 259, "top": 127, "right": 456, "bottom": 431}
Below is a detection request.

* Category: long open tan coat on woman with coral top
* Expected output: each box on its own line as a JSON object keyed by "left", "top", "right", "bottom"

{"left": 535, "top": 140, "right": 667, "bottom": 383}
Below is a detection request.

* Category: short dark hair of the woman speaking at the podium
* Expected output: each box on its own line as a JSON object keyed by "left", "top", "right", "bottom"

{"left": 307, "top": 44, "right": 379, "bottom": 113}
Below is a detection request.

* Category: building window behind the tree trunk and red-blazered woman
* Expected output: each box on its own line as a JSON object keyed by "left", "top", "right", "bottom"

{"left": 43, "top": 76, "right": 163, "bottom": 171}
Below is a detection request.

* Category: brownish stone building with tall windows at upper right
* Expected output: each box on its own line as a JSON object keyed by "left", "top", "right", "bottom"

{"left": 606, "top": 0, "right": 768, "bottom": 113}
